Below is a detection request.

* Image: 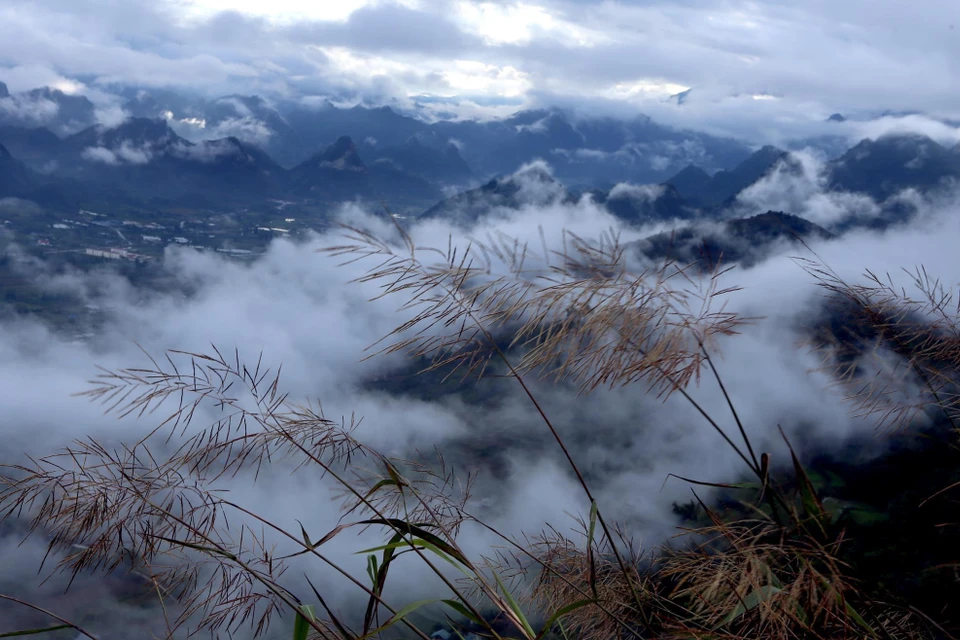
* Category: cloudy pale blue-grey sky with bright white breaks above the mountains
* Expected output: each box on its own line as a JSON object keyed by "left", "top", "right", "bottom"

{"left": 0, "top": 0, "right": 960, "bottom": 138}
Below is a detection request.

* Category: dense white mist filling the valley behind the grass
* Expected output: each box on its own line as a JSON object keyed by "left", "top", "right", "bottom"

{"left": 0, "top": 164, "right": 960, "bottom": 636}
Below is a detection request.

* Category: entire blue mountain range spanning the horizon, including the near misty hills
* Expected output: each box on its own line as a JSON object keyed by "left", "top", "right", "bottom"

{"left": 0, "top": 83, "right": 960, "bottom": 272}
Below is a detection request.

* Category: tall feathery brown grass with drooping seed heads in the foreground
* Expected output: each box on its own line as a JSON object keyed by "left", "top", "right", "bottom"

{"left": 0, "top": 221, "right": 960, "bottom": 640}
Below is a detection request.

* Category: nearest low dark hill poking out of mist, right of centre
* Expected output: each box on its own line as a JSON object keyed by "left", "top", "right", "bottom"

{"left": 630, "top": 211, "right": 833, "bottom": 270}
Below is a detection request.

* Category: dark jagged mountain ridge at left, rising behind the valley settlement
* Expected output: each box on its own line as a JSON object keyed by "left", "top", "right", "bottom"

{"left": 0, "top": 118, "right": 441, "bottom": 207}
